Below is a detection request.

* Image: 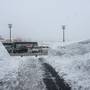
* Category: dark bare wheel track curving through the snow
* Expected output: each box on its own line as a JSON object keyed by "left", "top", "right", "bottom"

{"left": 39, "top": 58, "right": 71, "bottom": 90}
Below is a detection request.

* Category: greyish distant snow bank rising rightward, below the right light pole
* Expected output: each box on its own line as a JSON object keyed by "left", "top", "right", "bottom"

{"left": 49, "top": 40, "right": 90, "bottom": 56}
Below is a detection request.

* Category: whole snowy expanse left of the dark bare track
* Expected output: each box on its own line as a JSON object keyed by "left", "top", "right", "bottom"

{"left": 0, "top": 43, "right": 46, "bottom": 90}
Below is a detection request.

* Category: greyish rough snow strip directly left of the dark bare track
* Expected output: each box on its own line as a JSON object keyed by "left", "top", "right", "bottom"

{"left": 18, "top": 56, "right": 46, "bottom": 90}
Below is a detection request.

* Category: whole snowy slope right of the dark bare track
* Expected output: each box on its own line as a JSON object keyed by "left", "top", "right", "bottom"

{"left": 44, "top": 40, "right": 90, "bottom": 90}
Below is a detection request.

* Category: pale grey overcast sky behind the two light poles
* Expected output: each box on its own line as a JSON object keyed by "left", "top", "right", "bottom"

{"left": 0, "top": 0, "right": 90, "bottom": 41}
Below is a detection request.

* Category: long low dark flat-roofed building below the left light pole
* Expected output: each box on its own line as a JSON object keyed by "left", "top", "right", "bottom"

{"left": 3, "top": 42, "right": 38, "bottom": 53}
